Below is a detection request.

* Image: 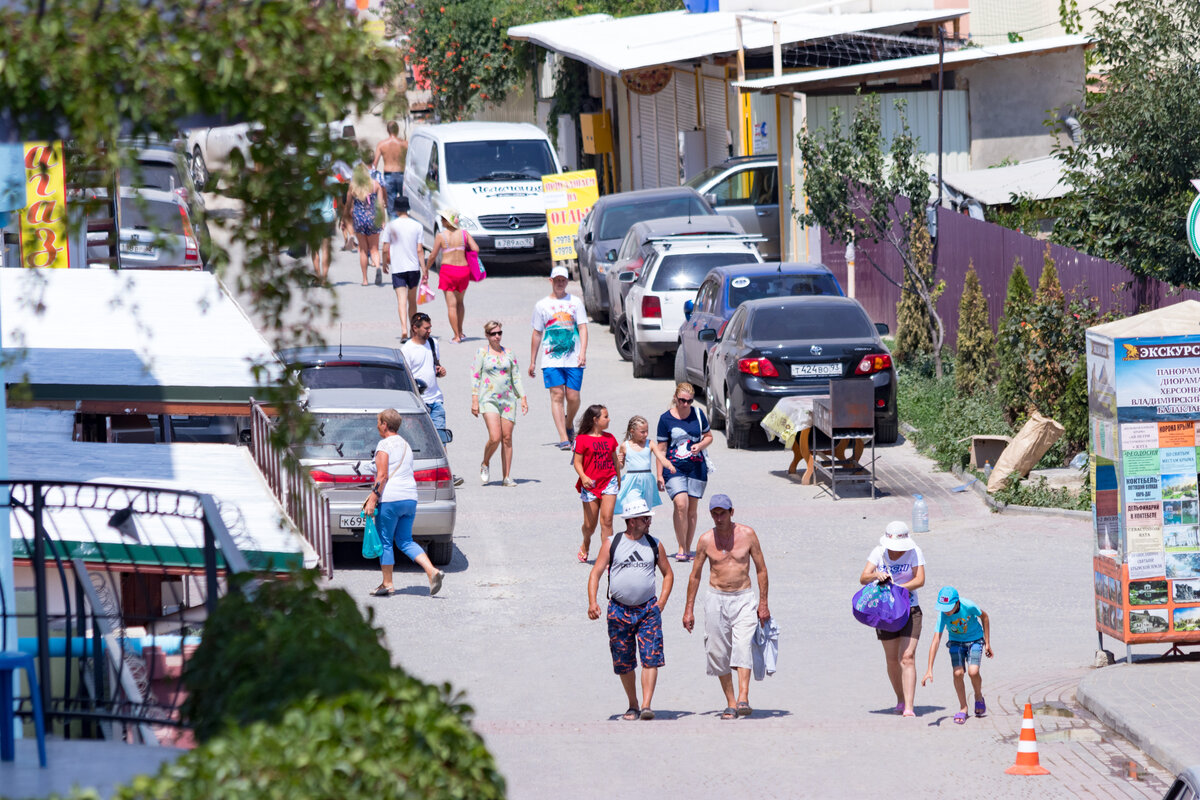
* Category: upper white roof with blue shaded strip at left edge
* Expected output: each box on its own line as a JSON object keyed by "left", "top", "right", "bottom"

{"left": 0, "top": 270, "right": 282, "bottom": 414}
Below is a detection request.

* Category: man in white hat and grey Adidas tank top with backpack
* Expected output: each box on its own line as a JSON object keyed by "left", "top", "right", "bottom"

{"left": 588, "top": 492, "right": 674, "bottom": 720}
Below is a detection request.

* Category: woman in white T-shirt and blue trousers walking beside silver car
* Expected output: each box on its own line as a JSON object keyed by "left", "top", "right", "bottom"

{"left": 362, "top": 408, "right": 446, "bottom": 597}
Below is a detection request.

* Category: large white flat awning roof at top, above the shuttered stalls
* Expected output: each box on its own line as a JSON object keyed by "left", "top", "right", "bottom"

{"left": 508, "top": 8, "right": 967, "bottom": 74}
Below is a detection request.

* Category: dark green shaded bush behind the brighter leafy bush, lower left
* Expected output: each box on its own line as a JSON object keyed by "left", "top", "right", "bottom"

{"left": 182, "top": 572, "right": 392, "bottom": 741}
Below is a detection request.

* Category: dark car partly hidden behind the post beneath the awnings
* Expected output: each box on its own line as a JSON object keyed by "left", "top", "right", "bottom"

{"left": 684, "top": 155, "right": 780, "bottom": 260}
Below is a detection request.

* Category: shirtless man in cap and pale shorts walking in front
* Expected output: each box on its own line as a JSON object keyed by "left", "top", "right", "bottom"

{"left": 683, "top": 494, "right": 770, "bottom": 720}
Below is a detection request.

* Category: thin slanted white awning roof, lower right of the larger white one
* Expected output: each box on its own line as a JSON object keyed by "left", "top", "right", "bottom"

{"left": 734, "top": 36, "right": 1094, "bottom": 92}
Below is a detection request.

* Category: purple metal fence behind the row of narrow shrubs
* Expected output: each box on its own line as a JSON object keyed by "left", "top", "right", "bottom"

{"left": 821, "top": 209, "right": 1200, "bottom": 348}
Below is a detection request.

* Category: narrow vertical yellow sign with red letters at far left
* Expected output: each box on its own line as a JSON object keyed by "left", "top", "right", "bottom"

{"left": 20, "top": 142, "right": 70, "bottom": 269}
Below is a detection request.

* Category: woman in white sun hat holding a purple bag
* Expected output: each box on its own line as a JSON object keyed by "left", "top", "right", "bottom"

{"left": 858, "top": 521, "right": 925, "bottom": 717}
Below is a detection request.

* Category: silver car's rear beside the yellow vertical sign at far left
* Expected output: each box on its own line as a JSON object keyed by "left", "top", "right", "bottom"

{"left": 86, "top": 186, "right": 204, "bottom": 270}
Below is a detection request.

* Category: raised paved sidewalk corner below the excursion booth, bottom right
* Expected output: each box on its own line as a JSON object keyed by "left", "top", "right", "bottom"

{"left": 1075, "top": 661, "right": 1200, "bottom": 775}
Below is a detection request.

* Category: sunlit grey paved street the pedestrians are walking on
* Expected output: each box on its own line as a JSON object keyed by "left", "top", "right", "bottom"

{"left": 225, "top": 245, "right": 1165, "bottom": 799}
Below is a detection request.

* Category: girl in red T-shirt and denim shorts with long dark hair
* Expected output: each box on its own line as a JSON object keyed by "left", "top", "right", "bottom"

{"left": 574, "top": 404, "right": 620, "bottom": 564}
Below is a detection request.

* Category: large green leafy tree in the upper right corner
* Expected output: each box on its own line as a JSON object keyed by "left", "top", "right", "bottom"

{"left": 1054, "top": 0, "right": 1200, "bottom": 285}
